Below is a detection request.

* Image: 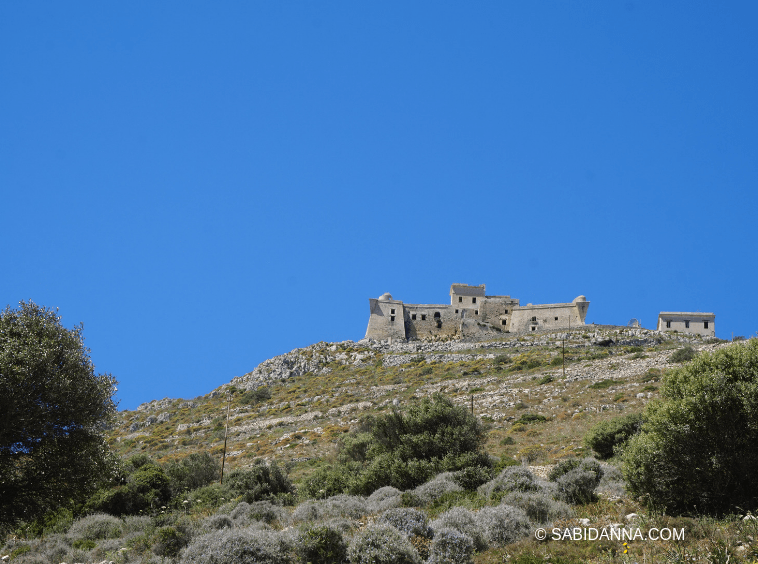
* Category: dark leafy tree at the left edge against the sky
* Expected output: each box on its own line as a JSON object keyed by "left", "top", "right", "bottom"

{"left": 0, "top": 302, "right": 116, "bottom": 525}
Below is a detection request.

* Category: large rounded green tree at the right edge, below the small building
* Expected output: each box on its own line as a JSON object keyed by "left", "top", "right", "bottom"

{"left": 624, "top": 339, "right": 758, "bottom": 514}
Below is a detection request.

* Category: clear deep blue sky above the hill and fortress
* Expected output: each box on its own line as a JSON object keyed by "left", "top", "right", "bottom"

{"left": 0, "top": 0, "right": 758, "bottom": 409}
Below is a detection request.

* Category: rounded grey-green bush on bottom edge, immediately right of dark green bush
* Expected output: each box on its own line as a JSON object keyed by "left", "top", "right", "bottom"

{"left": 347, "top": 525, "right": 421, "bottom": 564}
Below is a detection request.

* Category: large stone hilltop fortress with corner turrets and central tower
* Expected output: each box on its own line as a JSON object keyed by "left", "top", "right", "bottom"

{"left": 365, "top": 284, "right": 590, "bottom": 341}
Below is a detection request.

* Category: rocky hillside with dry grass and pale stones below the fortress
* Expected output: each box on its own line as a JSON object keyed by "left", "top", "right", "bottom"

{"left": 110, "top": 326, "right": 723, "bottom": 477}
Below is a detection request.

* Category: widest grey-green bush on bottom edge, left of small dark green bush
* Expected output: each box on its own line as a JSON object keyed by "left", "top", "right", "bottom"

{"left": 179, "top": 529, "right": 292, "bottom": 564}
